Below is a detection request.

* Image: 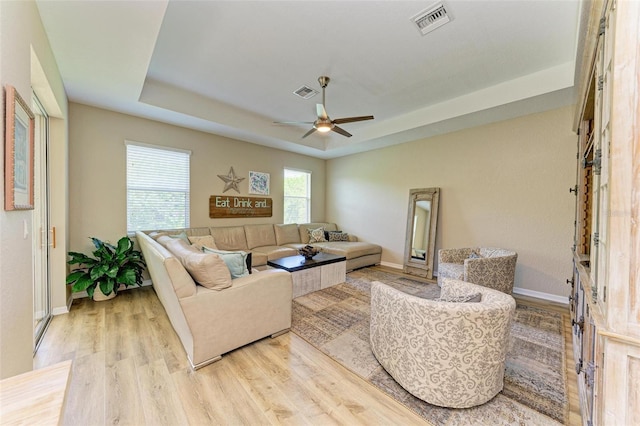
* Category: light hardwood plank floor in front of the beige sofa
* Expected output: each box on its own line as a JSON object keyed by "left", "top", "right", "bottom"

{"left": 34, "top": 274, "right": 580, "bottom": 425}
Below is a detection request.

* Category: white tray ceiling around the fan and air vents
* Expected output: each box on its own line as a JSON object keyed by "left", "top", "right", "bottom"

{"left": 37, "top": 0, "right": 580, "bottom": 158}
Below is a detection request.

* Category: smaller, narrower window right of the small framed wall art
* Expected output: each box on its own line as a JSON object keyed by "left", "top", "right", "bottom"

{"left": 284, "top": 169, "right": 311, "bottom": 223}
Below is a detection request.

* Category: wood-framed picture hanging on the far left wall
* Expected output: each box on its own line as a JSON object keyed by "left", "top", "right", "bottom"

{"left": 4, "top": 85, "right": 35, "bottom": 210}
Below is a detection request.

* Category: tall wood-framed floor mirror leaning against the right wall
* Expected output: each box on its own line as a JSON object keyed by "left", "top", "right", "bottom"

{"left": 404, "top": 188, "right": 440, "bottom": 279}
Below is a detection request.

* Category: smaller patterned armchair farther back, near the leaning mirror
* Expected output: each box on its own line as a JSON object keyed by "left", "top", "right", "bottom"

{"left": 438, "top": 247, "right": 518, "bottom": 294}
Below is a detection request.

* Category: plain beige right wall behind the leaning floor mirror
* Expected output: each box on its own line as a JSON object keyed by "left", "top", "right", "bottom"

{"left": 326, "top": 107, "right": 576, "bottom": 296}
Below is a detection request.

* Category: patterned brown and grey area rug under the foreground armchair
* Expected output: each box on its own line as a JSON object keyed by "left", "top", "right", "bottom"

{"left": 291, "top": 268, "right": 568, "bottom": 425}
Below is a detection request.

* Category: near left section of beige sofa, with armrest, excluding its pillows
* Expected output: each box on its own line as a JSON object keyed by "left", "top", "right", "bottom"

{"left": 136, "top": 232, "right": 292, "bottom": 368}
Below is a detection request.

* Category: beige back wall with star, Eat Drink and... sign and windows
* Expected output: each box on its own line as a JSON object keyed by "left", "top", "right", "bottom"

{"left": 69, "top": 103, "right": 325, "bottom": 252}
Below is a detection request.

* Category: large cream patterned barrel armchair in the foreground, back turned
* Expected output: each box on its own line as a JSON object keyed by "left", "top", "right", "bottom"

{"left": 370, "top": 279, "right": 516, "bottom": 408}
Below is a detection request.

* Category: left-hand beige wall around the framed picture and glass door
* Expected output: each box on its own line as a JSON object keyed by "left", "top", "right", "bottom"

{"left": 0, "top": 1, "right": 67, "bottom": 378}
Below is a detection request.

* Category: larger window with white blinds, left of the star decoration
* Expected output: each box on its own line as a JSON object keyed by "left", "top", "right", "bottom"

{"left": 125, "top": 142, "right": 191, "bottom": 232}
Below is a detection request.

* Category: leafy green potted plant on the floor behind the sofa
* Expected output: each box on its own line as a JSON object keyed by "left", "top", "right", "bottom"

{"left": 67, "top": 237, "right": 146, "bottom": 300}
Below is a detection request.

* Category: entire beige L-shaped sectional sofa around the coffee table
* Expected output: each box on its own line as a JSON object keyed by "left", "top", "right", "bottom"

{"left": 136, "top": 223, "right": 382, "bottom": 368}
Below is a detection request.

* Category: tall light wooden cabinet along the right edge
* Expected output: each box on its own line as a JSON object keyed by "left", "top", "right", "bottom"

{"left": 568, "top": 0, "right": 640, "bottom": 425}
